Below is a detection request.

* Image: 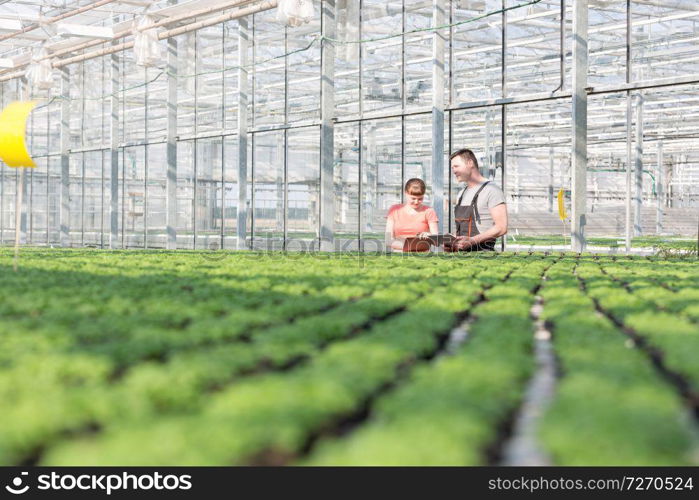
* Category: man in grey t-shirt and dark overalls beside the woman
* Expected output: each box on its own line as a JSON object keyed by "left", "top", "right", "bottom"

{"left": 444, "top": 149, "right": 507, "bottom": 252}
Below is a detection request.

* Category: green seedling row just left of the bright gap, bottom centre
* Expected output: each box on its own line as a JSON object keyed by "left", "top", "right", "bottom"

{"left": 301, "top": 260, "right": 551, "bottom": 465}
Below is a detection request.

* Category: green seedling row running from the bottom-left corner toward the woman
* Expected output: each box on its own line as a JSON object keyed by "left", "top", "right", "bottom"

{"left": 0, "top": 258, "right": 456, "bottom": 464}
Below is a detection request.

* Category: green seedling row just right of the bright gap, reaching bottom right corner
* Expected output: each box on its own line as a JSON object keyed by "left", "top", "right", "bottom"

{"left": 539, "top": 261, "right": 693, "bottom": 466}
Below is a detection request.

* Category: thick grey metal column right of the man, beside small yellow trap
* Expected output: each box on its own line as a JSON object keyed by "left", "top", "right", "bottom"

{"left": 570, "top": 0, "right": 588, "bottom": 252}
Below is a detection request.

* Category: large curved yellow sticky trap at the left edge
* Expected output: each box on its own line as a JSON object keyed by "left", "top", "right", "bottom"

{"left": 0, "top": 101, "right": 36, "bottom": 167}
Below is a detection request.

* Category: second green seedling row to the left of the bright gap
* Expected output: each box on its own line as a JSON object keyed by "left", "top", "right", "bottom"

{"left": 35, "top": 263, "right": 515, "bottom": 465}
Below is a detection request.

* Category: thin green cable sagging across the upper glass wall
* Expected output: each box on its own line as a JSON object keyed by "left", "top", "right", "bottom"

{"left": 34, "top": 0, "right": 542, "bottom": 110}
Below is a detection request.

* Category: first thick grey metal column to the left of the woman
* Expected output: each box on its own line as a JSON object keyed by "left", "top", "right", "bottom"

{"left": 320, "top": 0, "right": 337, "bottom": 252}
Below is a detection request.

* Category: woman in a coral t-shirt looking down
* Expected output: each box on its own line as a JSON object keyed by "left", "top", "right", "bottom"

{"left": 386, "top": 178, "right": 439, "bottom": 251}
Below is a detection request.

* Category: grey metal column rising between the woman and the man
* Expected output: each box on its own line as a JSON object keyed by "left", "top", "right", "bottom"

{"left": 434, "top": 0, "right": 446, "bottom": 233}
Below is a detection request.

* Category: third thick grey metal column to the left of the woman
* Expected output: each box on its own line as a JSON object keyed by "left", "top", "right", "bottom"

{"left": 165, "top": 31, "right": 177, "bottom": 250}
